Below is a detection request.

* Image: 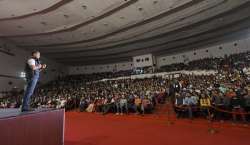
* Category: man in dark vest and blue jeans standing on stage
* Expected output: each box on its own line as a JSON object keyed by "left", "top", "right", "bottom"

{"left": 22, "top": 51, "right": 46, "bottom": 112}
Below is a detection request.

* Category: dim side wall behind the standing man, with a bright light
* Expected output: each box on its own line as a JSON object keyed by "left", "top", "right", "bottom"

{"left": 0, "top": 40, "right": 66, "bottom": 91}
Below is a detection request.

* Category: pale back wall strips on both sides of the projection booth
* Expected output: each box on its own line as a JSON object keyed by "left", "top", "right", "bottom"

{"left": 69, "top": 34, "right": 250, "bottom": 74}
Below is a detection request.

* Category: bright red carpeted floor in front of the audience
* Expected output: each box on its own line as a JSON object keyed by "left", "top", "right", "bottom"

{"left": 65, "top": 112, "right": 250, "bottom": 145}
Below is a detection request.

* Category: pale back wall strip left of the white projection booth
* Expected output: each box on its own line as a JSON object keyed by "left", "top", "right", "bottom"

{"left": 69, "top": 61, "right": 133, "bottom": 74}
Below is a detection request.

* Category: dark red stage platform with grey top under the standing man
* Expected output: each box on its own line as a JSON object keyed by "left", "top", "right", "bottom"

{"left": 0, "top": 109, "right": 65, "bottom": 145}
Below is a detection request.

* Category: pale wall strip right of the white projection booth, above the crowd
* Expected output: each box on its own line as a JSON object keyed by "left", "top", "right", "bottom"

{"left": 157, "top": 37, "right": 250, "bottom": 67}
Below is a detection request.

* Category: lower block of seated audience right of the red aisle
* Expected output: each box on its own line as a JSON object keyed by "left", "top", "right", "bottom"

{"left": 175, "top": 70, "right": 250, "bottom": 122}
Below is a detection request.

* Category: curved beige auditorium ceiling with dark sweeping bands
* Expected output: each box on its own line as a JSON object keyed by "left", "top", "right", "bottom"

{"left": 0, "top": 0, "right": 250, "bottom": 65}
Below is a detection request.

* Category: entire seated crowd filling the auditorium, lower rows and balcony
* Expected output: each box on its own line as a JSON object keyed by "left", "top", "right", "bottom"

{"left": 0, "top": 52, "right": 250, "bottom": 122}
